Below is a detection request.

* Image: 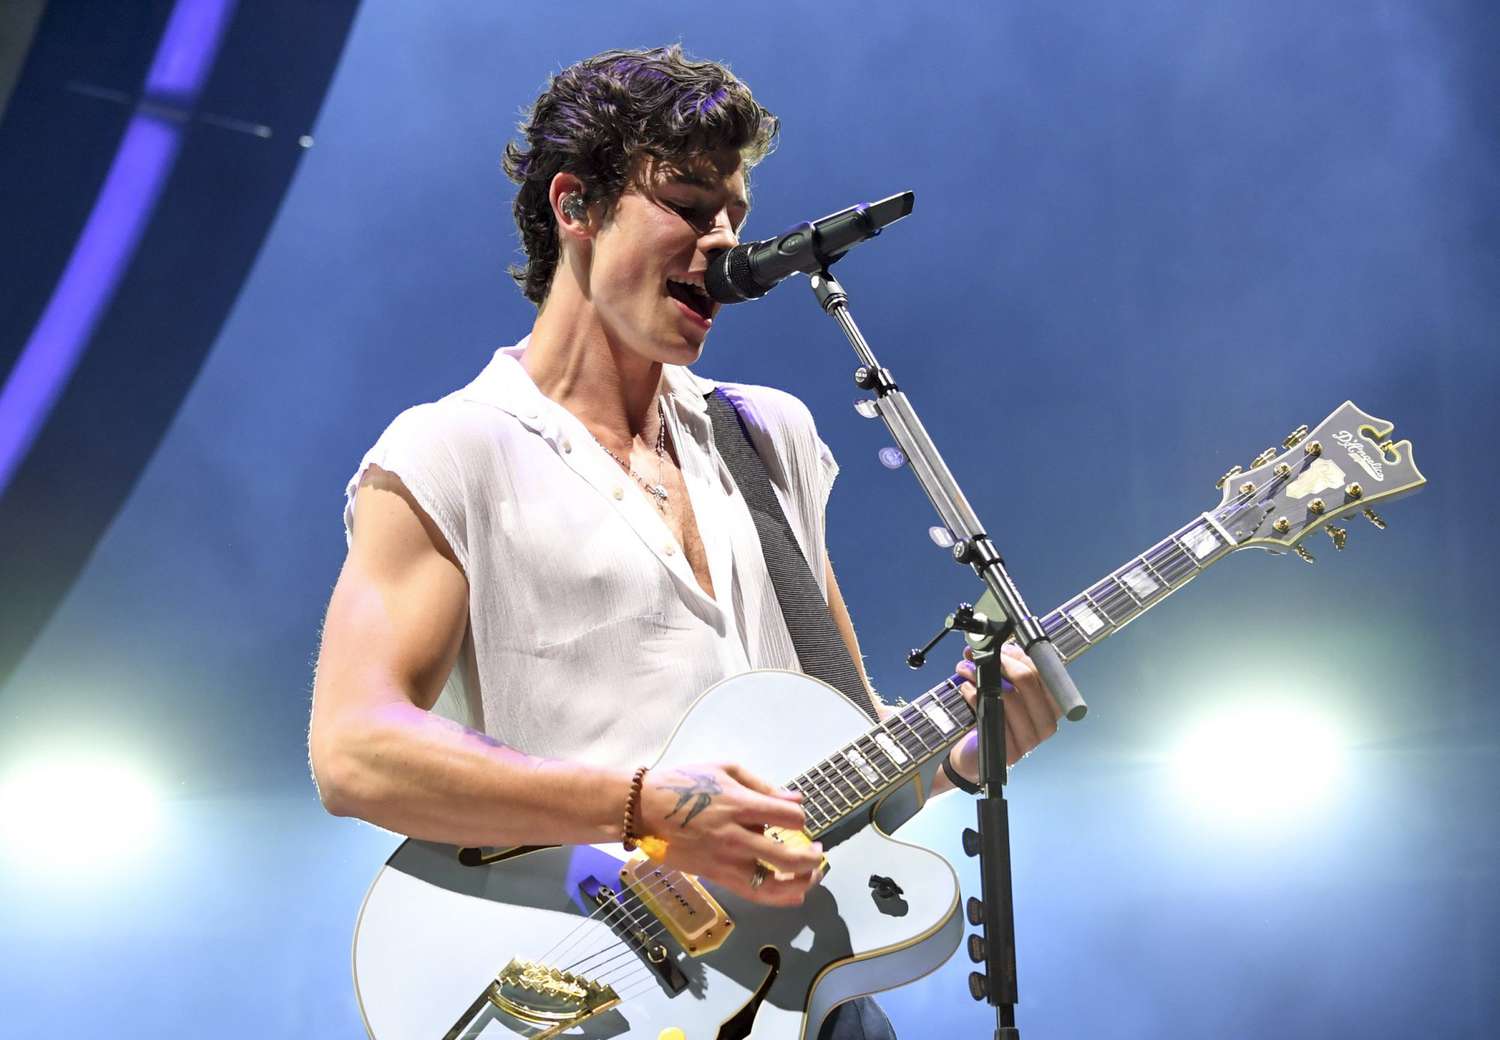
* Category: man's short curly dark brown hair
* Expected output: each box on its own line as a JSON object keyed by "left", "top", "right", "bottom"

{"left": 504, "top": 44, "right": 779, "bottom": 306}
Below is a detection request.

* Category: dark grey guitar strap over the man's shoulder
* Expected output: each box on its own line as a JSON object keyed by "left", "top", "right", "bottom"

{"left": 705, "top": 389, "right": 879, "bottom": 722}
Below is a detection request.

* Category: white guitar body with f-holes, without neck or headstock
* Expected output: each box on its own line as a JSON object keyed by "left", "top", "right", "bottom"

{"left": 354, "top": 671, "right": 963, "bottom": 1040}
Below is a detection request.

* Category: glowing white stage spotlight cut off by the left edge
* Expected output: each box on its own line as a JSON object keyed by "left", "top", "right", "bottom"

{"left": 0, "top": 755, "right": 161, "bottom": 872}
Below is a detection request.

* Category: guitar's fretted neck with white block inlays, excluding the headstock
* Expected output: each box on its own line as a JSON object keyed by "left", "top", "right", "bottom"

{"left": 786, "top": 513, "right": 1235, "bottom": 837}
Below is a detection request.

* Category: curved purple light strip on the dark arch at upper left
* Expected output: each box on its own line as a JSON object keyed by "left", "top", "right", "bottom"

{"left": 0, "top": 0, "right": 236, "bottom": 495}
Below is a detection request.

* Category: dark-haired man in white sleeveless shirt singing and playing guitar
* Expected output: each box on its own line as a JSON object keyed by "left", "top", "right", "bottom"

{"left": 309, "top": 47, "right": 1058, "bottom": 1040}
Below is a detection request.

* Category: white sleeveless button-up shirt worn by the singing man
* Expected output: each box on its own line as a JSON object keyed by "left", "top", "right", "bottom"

{"left": 344, "top": 339, "right": 839, "bottom": 765}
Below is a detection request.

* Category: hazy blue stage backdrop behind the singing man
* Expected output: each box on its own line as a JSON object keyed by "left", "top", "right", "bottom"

{"left": 0, "top": 0, "right": 1500, "bottom": 1040}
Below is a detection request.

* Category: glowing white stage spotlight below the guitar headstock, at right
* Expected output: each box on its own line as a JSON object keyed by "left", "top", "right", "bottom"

{"left": 1175, "top": 704, "right": 1343, "bottom": 821}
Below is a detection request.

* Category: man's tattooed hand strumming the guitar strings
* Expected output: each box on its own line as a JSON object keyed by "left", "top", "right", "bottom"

{"left": 638, "top": 764, "right": 824, "bottom": 906}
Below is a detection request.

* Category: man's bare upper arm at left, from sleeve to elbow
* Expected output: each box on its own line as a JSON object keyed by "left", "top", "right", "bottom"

{"left": 312, "top": 467, "right": 468, "bottom": 726}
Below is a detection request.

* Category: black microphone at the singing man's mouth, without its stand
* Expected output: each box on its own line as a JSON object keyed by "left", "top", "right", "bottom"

{"left": 704, "top": 192, "right": 917, "bottom": 303}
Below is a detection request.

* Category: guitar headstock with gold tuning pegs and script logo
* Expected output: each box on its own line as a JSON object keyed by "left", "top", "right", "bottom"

{"left": 1212, "top": 401, "right": 1427, "bottom": 563}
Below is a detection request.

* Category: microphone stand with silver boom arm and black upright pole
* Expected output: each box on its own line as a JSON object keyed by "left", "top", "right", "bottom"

{"left": 810, "top": 266, "right": 1088, "bottom": 1040}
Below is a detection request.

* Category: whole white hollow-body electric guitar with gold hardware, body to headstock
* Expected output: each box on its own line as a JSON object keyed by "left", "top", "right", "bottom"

{"left": 354, "top": 402, "right": 1425, "bottom": 1040}
